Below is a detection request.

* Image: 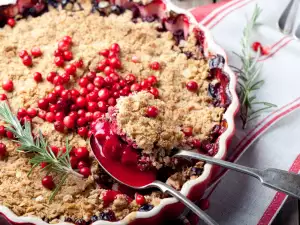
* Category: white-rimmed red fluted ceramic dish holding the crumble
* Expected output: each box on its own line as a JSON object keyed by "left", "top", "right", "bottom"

{"left": 0, "top": 0, "right": 239, "bottom": 225}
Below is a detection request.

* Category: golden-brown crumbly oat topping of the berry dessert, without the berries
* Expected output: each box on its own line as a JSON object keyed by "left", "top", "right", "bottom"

{"left": 0, "top": 1, "right": 224, "bottom": 223}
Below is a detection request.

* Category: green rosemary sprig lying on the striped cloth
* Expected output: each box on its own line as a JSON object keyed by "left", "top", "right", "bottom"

{"left": 231, "top": 5, "right": 276, "bottom": 129}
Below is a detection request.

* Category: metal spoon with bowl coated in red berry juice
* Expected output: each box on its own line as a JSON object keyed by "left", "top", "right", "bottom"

{"left": 90, "top": 135, "right": 217, "bottom": 225}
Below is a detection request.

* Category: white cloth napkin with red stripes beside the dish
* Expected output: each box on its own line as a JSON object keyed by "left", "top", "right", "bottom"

{"left": 186, "top": 0, "right": 300, "bottom": 225}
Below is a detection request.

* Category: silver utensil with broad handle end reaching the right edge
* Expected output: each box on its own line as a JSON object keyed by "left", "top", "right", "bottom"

{"left": 173, "top": 150, "right": 300, "bottom": 199}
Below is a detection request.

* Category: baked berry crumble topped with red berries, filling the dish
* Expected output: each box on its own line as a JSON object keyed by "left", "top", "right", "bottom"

{"left": 0, "top": 1, "right": 230, "bottom": 225}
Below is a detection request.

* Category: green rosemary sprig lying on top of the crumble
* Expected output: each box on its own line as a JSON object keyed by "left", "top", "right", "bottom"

{"left": 0, "top": 101, "right": 83, "bottom": 201}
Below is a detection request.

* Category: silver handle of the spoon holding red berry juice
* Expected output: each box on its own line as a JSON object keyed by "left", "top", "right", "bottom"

{"left": 151, "top": 181, "right": 218, "bottom": 225}
